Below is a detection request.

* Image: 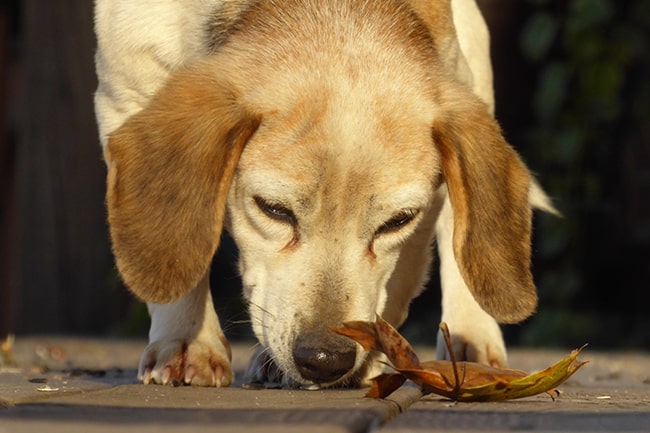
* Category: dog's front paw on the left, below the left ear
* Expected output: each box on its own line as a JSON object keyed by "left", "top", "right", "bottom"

{"left": 138, "top": 339, "right": 234, "bottom": 387}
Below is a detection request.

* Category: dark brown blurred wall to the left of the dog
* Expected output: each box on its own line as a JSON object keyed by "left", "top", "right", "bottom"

{"left": 0, "top": 0, "right": 125, "bottom": 333}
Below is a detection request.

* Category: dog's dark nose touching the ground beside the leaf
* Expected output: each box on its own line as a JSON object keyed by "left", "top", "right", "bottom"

{"left": 293, "top": 345, "right": 356, "bottom": 384}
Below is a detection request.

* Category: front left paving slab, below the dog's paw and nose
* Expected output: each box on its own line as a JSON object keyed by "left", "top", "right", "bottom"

{"left": 0, "top": 385, "right": 420, "bottom": 433}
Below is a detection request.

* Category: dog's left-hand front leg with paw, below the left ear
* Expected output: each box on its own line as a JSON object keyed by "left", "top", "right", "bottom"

{"left": 138, "top": 274, "right": 233, "bottom": 386}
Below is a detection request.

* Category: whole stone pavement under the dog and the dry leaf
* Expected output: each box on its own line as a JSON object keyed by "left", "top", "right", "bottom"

{"left": 0, "top": 337, "right": 650, "bottom": 433}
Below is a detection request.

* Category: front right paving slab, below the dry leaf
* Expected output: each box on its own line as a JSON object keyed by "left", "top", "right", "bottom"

{"left": 379, "top": 388, "right": 650, "bottom": 433}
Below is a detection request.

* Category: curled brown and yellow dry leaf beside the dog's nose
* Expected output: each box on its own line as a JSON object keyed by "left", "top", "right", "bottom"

{"left": 334, "top": 316, "right": 586, "bottom": 401}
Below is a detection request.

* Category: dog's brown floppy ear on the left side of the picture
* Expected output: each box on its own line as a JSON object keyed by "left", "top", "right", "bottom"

{"left": 106, "top": 65, "right": 260, "bottom": 303}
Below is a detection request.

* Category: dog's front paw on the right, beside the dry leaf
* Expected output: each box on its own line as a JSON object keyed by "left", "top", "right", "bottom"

{"left": 436, "top": 314, "right": 507, "bottom": 367}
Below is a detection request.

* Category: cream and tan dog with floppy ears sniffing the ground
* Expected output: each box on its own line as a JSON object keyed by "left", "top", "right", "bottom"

{"left": 95, "top": 0, "right": 554, "bottom": 388}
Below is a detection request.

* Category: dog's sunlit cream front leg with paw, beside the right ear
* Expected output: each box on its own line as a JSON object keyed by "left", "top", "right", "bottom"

{"left": 436, "top": 191, "right": 506, "bottom": 367}
